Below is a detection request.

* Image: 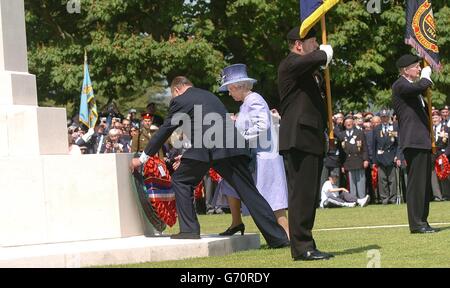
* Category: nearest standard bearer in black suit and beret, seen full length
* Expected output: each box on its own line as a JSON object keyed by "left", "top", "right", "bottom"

{"left": 278, "top": 27, "right": 333, "bottom": 260}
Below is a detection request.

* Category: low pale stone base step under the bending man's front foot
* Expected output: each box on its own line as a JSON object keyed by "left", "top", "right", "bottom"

{"left": 0, "top": 234, "right": 260, "bottom": 268}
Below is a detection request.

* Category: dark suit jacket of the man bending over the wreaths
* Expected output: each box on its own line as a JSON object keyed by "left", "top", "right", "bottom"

{"left": 144, "top": 87, "right": 250, "bottom": 162}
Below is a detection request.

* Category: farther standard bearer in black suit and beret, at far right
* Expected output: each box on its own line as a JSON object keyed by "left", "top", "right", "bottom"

{"left": 392, "top": 54, "right": 436, "bottom": 233}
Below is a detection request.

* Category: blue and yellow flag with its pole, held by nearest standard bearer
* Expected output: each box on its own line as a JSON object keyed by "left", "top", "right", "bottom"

{"left": 300, "top": 0, "right": 339, "bottom": 145}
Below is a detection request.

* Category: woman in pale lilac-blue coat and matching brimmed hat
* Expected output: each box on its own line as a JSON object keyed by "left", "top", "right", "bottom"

{"left": 219, "top": 64, "right": 289, "bottom": 235}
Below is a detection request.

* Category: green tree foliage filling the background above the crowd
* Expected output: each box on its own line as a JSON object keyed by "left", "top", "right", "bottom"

{"left": 25, "top": 0, "right": 450, "bottom": 116}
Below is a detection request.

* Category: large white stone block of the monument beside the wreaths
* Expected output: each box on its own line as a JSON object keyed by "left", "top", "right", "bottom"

{"left": 0, "top": 154, "right": 151, "bottom": 246}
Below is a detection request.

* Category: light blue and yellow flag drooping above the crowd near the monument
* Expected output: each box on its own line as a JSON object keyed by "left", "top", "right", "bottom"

{"left": 80, "top": 53, "right": 98, "bottom": 128}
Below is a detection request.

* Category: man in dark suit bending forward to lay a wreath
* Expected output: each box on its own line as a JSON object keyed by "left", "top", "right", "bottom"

{"left": 131, "top": 76, "right": 289, "bottom": 248}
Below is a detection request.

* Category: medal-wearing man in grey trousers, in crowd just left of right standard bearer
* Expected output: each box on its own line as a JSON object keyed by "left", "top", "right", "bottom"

{"left": 373, "top": 110, "right": 398, "bottom": 204}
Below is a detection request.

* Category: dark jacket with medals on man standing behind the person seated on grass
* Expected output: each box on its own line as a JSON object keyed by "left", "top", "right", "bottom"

{"left": 339, "top": 128, "right": 369, "bottom": 170}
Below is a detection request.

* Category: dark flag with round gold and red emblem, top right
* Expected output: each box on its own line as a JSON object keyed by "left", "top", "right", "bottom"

{"left": 405, "top": 0, "right": 441, "bottom": 71}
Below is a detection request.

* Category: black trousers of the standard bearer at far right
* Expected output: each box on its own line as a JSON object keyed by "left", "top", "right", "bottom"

{"left": 403, "top": 148, "right": 432, "bottom": 230}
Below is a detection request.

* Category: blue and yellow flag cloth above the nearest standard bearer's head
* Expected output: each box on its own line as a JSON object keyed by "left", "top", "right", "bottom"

{"left": 300, "top": 0, "right": 339, "bottom": 38}
